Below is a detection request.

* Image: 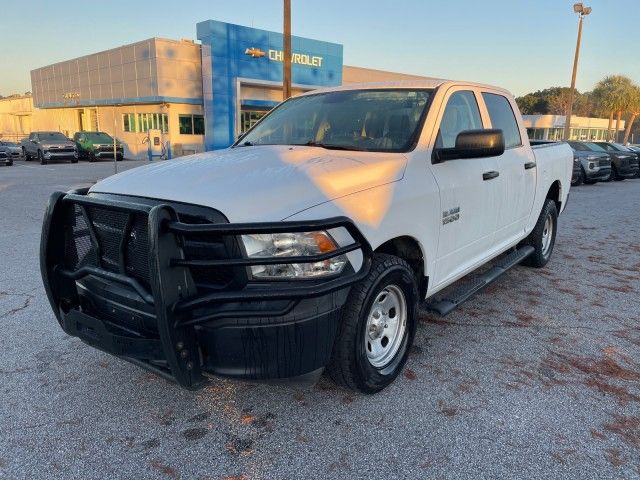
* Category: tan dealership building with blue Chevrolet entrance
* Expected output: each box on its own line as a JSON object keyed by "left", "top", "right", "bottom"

{"left": 31, "top": 20, "right": 432, "bottom": 158}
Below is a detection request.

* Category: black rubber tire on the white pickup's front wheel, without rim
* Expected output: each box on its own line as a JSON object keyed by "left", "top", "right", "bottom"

{"left": 326, "top": 254, "right": 418, "bottom": 394}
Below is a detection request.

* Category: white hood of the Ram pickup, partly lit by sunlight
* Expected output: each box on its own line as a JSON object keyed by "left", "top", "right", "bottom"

{"left": 90, "top": 145, "right": 407, "bottom": 222}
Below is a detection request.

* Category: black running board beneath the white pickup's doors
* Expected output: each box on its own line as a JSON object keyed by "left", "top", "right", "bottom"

{"left": 424, "top": 245, "right": 535, "bottom": 316}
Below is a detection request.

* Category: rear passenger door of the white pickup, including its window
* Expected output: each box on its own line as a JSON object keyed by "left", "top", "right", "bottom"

{"left": 481, "top": 91, "right": 537, "bottom": 250}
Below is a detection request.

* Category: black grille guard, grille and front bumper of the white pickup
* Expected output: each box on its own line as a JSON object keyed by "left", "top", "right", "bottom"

{"left": 40, "top": 192, "right": 372, "bottom": 389}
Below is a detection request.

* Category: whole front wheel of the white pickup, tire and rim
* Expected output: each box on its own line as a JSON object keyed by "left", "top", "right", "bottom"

{"left": 327, "top": 254, "right": 418, "bottom": 394}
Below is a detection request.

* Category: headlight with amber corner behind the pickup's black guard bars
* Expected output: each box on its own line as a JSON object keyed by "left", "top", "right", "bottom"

{"left": 242, "top": 231, "right": 347, "bottom": 278}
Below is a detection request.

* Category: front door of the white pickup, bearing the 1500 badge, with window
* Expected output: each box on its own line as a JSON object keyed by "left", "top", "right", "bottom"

{"left": 431, "top": 87, "right": 498, "bottom": 288}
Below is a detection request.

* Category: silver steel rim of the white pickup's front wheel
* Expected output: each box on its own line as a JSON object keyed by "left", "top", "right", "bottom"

{"left": 364, "top": 285, "right": 407, "bottom": 368}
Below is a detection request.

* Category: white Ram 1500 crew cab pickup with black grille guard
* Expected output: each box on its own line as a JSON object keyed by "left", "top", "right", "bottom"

{"left": 41, "top": 80, "right": 573, "bottom": 393}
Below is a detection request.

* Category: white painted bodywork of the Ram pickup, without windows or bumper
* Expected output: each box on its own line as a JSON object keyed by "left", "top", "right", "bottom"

{"left": 91, "top": 80, "right": 573, "bottom": 297}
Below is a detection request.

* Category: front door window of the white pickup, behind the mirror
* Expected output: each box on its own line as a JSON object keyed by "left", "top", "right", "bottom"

{"left": 435, "top": 90, "right": 482, "bottom": 148}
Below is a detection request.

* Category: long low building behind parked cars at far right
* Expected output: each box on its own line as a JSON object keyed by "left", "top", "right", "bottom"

{"left": 523, "top": 115, "right": 625, "bottom": 141}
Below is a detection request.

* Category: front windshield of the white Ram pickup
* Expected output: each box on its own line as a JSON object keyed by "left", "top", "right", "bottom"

{"left": 236, "top": 89, "right": 433, "bottom": 152}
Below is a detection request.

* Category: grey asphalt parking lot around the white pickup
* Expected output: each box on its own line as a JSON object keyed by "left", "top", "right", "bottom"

{"left": 0, "top": 160, "right": 640, "bottom": 479}
